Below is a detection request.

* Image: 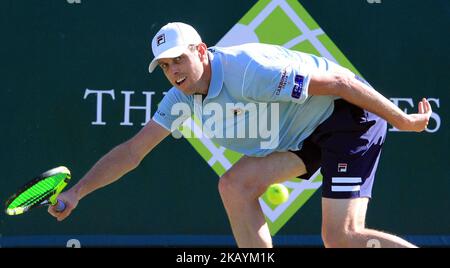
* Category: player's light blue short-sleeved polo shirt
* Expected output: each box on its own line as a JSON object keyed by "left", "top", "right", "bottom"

{"left": 152, "top": 43, "right": 342, "bottom": 156}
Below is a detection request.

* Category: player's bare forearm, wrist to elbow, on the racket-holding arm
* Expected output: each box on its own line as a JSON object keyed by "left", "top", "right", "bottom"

{"left": 71, "top": 143, "right": 139, "bottom": 199}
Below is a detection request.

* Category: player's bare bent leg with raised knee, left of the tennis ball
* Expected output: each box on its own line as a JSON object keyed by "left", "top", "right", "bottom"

{"left": 219, "top": 152, "right": 306, "bottom": 248}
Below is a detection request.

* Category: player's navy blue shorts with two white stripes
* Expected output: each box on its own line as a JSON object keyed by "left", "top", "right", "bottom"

{"left": 291, "top": 99, "right": 387, "bottom": 199}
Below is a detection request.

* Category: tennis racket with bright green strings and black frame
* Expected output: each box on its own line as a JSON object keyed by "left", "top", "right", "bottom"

{"left": 5, "top": 166, "right": 71, "bottom": 215}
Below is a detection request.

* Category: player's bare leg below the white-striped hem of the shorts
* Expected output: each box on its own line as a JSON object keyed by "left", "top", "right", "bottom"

{"left": 322, "top": 198, "right": 416, "bottom": 248}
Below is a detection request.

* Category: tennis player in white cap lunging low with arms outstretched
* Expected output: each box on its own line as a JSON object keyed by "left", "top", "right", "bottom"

{"left": 49, "top": 23, "right": 432, "bottom": 247}
